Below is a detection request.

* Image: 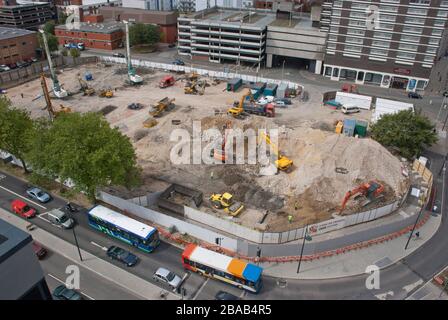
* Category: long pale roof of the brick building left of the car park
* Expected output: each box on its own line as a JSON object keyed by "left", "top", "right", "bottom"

{"left": 99, "top": 6, "right": 177, "bottom": 25}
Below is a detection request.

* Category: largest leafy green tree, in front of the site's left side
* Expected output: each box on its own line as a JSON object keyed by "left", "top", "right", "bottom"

{"left": 28, "top": 112, "right": 140, "bottom": 201}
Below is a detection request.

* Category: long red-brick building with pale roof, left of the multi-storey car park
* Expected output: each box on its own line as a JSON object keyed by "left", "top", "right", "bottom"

{"left": 98, "top": 7, "right": 177, "bottom": 43}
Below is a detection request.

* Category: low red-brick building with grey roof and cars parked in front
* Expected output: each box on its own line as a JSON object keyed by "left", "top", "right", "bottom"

{"left": 55, "top": 22, "right": 124, "bottom": 50}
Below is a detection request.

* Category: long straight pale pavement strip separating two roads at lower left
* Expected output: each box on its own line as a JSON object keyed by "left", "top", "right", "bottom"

{"left": 0, "top": 208, "right": 180, "bottom": 300}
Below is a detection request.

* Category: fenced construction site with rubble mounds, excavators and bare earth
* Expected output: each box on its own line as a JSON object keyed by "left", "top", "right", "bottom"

{"left": 3, "top": 29, "right": 409, "bottom": 232}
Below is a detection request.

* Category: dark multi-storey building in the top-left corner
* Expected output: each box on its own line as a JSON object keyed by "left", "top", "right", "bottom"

{"left": 0, "top": 0, "right": 54, "bottom": 30}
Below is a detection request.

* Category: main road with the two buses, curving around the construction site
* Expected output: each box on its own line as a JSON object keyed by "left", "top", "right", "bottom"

{"left": 0, "top": 148, "right": 448, "bottom": 300}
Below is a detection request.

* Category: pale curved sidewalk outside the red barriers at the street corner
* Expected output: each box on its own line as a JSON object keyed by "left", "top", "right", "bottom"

{"left": 260, "top": 214, "right": 442, "bottom": 280}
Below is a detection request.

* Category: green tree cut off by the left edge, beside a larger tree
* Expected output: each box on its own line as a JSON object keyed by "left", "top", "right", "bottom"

{"left": 0, "top": 97, "right": 34, "bottom": 172}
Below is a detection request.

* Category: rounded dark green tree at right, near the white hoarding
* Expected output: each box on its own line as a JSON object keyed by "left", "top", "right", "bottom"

{"left": 370, "top": 110, "right": 437, "bottom": 158}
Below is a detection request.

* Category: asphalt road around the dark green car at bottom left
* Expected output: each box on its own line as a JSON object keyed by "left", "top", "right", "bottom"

{"left": 40, "top": 249, "right": 140, "bottom": 300}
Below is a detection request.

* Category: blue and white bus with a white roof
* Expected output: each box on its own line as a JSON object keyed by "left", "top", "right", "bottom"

{"left": 87, "top": 205, "right": 160, "bottom": 252}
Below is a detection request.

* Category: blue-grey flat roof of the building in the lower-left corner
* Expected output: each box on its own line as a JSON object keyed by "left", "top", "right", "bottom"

{"left": 0, "top": 219, "right": 31, "bottom": 264}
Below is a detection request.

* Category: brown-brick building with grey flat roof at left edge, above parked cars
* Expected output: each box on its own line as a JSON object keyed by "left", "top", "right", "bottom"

{"left": 0, "top": 27, "right": 38, "bottom": 64}
